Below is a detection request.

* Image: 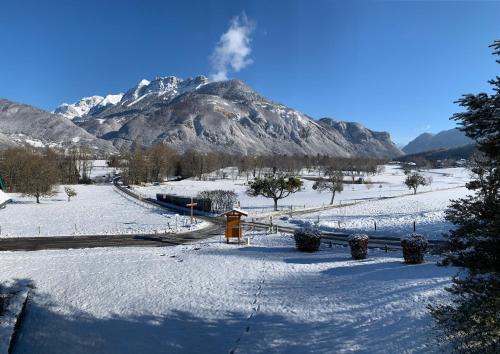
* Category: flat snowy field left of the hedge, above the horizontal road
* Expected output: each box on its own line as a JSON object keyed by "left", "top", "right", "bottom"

{"left": 0, "top": 185, "right": 206, "bottom": 237}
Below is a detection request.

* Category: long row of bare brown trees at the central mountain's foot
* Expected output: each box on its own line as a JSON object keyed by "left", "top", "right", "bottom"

{"left": 118, "top": 144, "right": 384, "bottom": 184}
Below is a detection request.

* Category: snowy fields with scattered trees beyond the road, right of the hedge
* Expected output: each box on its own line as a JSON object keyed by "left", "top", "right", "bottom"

{"left": 135, "top": 165, "right": 470, "bottom": 238}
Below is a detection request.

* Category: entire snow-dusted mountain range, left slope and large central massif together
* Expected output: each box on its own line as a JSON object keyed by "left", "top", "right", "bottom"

{"left": 0, "top": 76, "right": 402, "bottom": 158}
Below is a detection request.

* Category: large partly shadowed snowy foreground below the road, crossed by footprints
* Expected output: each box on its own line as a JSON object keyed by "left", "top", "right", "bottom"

{"left": 0, "top": 235, "right": 456, "bottom": 354}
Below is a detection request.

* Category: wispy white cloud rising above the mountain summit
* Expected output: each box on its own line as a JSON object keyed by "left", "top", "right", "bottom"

{"left": 210, "top": 13, "right": 255, "bottom": 81}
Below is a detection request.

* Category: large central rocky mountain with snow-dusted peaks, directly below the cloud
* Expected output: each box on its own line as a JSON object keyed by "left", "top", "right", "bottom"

{"left": 55, "top": 76, "right": 402, "bottom": 157}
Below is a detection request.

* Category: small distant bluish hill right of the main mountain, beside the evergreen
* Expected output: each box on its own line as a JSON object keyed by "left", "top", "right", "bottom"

{"left": 403, "top": 128, "right": 474, "bottom": 154}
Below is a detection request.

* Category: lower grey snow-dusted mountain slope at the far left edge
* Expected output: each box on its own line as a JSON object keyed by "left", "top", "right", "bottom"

{"left": 0, "top": 99, "right": 116, "bottom": 154}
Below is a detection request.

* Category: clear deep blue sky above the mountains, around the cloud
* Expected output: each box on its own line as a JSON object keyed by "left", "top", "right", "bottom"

{"left": 0, "top": 0, "right": 500, "bottom": 143}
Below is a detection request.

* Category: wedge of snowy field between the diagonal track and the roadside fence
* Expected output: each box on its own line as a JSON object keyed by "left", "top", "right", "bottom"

{"left": 279, "top": 187, "right": 470, "bottom": 239}
